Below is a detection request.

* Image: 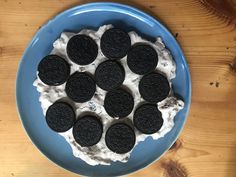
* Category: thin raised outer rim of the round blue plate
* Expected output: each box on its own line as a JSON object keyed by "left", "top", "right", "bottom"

{"left": 15, "top": 2, "right": 192, "bottom": 176}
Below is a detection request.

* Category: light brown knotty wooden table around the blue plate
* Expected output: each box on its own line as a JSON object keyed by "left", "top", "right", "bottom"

{"left": 0, "top": 0, "right": 236, "bottom": 177}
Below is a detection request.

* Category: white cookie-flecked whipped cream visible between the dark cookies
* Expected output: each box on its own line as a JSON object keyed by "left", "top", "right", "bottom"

{"left": 33, "top": 25, "right": 184, "bottom": 165}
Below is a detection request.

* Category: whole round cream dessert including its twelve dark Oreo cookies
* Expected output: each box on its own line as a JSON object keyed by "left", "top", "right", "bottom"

{"left": 33, "top": 25, "right": 184, "bottom": 165}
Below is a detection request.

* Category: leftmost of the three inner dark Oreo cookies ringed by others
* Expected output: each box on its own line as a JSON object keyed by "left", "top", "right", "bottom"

{"left": 65, "top": 72, "right": 96, "bottom": 103}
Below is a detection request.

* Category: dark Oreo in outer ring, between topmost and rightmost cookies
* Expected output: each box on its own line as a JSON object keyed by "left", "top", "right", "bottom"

{"left": 127, "top": 43, "right": 158, "bottom": 75}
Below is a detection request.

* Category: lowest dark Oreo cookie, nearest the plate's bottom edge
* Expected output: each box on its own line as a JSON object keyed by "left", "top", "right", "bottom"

{"left": 105, "top": 123, "right": 135, "bottom": 154}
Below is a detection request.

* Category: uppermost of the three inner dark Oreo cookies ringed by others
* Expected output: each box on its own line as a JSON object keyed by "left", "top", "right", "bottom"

{"left": 95, "top": 60, "right": 125, "bottom": 91}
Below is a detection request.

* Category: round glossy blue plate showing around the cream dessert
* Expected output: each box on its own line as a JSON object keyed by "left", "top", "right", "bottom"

{"left": 16, "top": 3, "right": 191, "bottom": 176}
